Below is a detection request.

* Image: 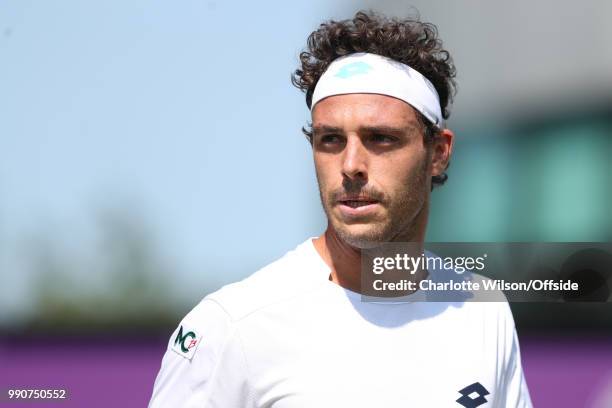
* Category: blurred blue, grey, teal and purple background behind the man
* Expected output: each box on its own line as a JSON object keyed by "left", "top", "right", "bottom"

{"left": 0, "top": 0, "right": 612, "bottom": 408}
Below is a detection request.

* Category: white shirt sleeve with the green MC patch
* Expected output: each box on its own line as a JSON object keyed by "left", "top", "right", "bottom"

{"left": 149, "top": 299, "right": 251, "bottom": 408}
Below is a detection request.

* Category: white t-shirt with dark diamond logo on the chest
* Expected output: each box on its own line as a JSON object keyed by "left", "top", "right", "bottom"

{"left": 149, "top": 239, "right": 532, "bottom": 408}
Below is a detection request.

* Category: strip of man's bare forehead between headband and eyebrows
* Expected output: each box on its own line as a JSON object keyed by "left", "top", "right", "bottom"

{"left": 312, "top": 94, "right": 417, "bottom": 126}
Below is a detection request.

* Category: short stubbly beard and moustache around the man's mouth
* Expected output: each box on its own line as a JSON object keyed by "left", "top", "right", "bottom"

{"left": 317, "top": 161, "right": 430, "bottom": 249}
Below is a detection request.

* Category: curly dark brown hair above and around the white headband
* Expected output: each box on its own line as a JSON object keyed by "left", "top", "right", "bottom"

{"left": 291, "top": 11, "right": 456, "bottom": 188}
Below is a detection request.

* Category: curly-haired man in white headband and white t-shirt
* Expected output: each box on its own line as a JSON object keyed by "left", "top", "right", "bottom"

{"left": 150, "top": 12, "right": 531, "bottom": 408}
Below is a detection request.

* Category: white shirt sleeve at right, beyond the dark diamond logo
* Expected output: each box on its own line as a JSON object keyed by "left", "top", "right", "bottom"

{"left": 498, "top": 302, "right": 533, "bottom": 408}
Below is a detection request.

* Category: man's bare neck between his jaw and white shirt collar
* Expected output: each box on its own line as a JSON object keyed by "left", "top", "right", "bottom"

{"left": 313, "top": 206, "right": 428, "bottom": 293}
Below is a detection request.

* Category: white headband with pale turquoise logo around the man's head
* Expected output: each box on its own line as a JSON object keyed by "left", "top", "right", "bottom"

{"left": 310, "top": 52, "right": 443, "bottom": 128}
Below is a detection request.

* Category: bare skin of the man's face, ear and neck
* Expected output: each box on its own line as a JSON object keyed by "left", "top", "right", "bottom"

{"left": 312, "top": 94, "right": 454, "bottom": 293}
